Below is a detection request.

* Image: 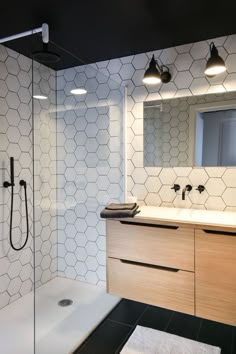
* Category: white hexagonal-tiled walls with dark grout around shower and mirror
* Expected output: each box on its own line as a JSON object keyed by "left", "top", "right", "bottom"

{"left": 0, "top": 31, "right": 236, "bottom": 306}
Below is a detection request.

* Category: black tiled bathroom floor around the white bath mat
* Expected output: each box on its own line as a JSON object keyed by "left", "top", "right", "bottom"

{"left": 73, "top": 300, "right": 236, "bottom": 354}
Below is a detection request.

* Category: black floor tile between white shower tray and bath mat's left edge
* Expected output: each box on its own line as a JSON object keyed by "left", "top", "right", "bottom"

{"left": 73, "top": 319, "right": 132, "bottom": 354}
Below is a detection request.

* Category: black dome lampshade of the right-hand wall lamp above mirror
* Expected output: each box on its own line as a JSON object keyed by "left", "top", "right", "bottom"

{"left": 205, "top": 42, "right": 226, "bottom": 77}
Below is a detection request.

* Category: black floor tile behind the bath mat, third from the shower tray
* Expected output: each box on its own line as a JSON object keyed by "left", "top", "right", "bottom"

{"left": 166, "top": 312, "right": 201, "bottom": 340}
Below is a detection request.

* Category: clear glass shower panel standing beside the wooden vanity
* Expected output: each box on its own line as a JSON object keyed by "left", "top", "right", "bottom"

{"left": 33, "top": 43, "right": 124, "bottom": 354}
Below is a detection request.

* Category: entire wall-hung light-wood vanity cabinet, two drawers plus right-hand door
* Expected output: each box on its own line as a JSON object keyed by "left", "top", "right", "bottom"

{"left": 107, "top": 220, "right": 236, "bottom": 326}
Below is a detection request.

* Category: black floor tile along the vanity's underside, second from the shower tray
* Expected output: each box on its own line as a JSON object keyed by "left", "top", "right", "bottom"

{"left": 138, "top": 306, "right": 173, "bottom": 331}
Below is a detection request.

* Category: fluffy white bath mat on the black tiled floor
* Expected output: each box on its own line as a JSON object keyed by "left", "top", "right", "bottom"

{"left": 120, "top": 326, "right": 221, "bottom": 354}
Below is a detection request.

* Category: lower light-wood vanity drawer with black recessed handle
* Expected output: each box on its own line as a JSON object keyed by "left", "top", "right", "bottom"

{"left": 108, "top": 258, "right": 194, "bottom": 314}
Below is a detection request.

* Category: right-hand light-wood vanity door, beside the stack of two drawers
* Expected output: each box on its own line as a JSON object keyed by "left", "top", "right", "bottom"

{"left": 195, "top": 229, "right": 236, "bottom": 325}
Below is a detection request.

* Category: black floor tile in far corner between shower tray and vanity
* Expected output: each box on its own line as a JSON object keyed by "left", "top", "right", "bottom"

{"left": 108, "top": 299, "right": 148, "bottom": 326}
